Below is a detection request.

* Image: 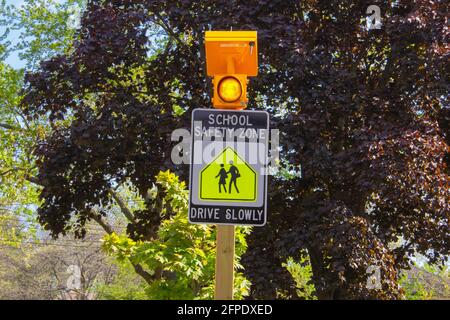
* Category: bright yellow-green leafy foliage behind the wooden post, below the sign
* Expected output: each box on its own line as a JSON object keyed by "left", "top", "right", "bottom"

{"left": 104, "top": 171, "right": 250, "bottom": 299}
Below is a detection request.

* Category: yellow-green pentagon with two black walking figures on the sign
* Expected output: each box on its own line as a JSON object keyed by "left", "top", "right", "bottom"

{"left": 199, "top": 148, "right": 258, "bottom": 202}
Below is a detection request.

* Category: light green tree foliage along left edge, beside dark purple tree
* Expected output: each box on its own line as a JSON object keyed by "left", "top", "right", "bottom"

{"left": 0, "top": 0, "right": 84, "bottom": 243}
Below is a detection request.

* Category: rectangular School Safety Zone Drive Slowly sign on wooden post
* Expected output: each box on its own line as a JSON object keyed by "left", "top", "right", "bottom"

{"left": 189, "top": 109, "right": 269, "bottom": 226}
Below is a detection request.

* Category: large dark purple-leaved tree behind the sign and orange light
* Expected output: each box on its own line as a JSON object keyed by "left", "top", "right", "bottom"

{"left": 15, "top": 0, "right": 450, "bottom": 298}
